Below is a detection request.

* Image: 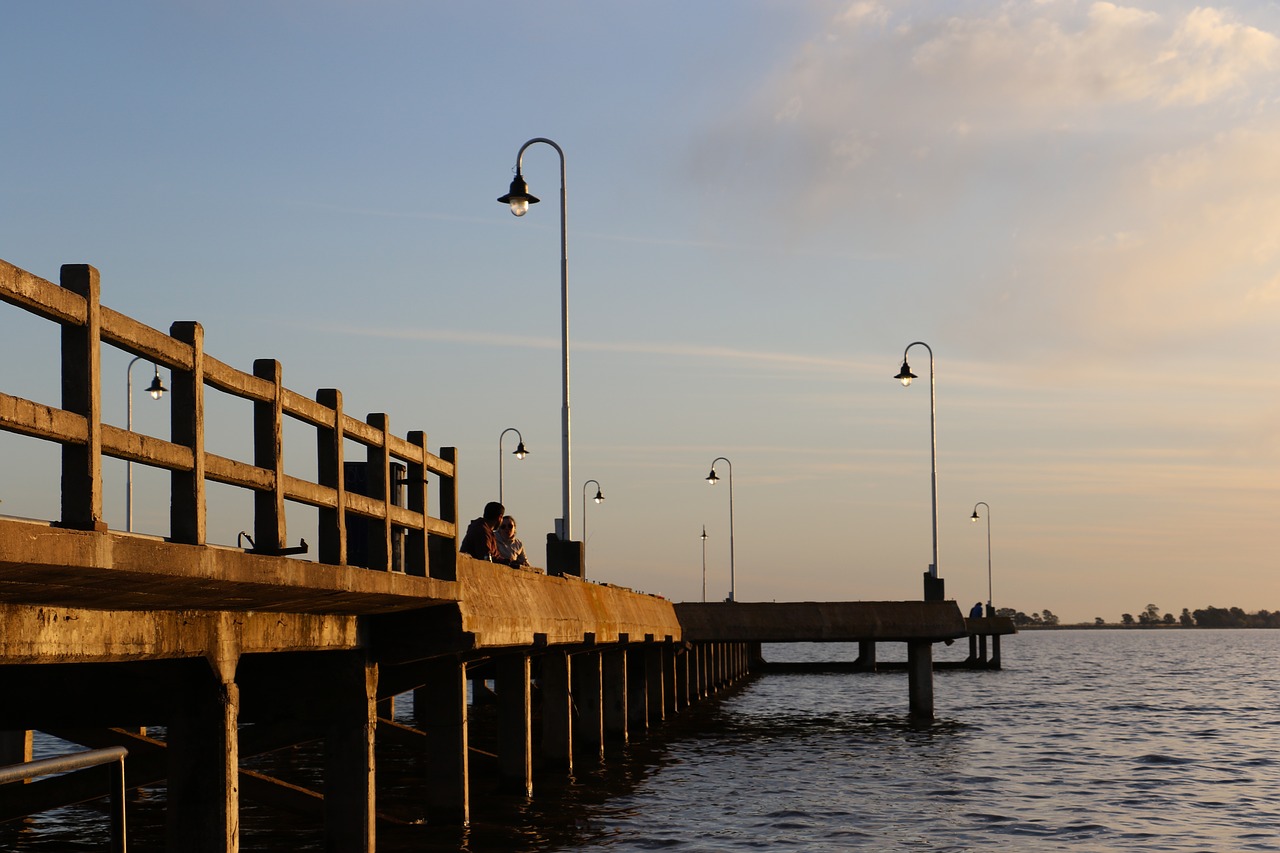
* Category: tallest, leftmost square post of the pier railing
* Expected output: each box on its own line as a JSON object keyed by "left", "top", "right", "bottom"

{"left": 60, "top": 264, "right": 106, "bottom": 530}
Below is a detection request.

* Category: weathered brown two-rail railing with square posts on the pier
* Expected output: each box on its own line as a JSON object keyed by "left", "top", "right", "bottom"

{"left": 0, "top": 260, "right": 457, "bottom": 580}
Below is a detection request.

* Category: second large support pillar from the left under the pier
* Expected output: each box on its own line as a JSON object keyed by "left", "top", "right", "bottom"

{"left": 324, "top": 652, "right": 376, "bottom": 853}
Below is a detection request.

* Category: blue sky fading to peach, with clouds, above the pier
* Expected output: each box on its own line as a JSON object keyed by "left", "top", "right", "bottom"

{"left": 0, "top": 0, "right": 1280, "bottom": 622}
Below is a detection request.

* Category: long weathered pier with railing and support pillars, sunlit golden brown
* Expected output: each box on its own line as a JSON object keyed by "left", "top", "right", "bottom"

{"left": 0, "top": 261, "right": 977, "bottom": 853}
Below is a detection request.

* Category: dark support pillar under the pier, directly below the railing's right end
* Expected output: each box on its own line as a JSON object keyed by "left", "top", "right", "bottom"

{"left": 413, "top": 658, "right": 471, "bottom": 825}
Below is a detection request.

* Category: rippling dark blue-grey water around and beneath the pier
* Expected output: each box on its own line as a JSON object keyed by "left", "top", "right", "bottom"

{"left": 0, "top": 630, "right": 1280, "bottom": 853}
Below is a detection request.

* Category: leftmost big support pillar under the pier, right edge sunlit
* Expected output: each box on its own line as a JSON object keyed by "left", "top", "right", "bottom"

{"left": 165, "top": 660, "right": 239, "bottom": 853}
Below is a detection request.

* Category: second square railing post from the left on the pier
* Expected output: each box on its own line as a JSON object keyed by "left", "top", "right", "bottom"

{"left": 169, "top": 321, "right": 206, "bottom": 544}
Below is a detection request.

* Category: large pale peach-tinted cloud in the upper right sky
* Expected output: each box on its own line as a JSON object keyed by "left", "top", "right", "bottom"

{"left": 703, "top": 0, "right": 1280, "bottom": 353}
